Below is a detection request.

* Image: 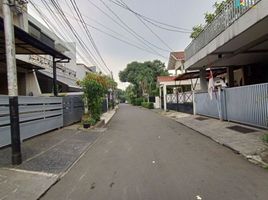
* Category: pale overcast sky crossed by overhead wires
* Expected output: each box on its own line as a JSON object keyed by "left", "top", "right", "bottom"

{"left": 28, "top": 0, "right": 216, "bottom": 89}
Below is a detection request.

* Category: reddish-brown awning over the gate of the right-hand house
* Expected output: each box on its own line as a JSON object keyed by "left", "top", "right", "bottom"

{"left": 174, "top": 68, "right": 227, "bottom": 81}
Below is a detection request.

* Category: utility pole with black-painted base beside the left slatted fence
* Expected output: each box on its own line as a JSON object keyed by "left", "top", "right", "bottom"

{"left": 3, "top": 0, "right": 22, "bottom": 165}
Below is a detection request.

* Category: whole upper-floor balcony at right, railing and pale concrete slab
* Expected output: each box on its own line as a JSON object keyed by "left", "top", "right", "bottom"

{"left": 185, "top": 0, "right": 268, "bottom": 69}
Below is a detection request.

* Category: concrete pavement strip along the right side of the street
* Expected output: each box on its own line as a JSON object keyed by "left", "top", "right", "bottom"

{"left": 155, "top": 110, "right": 268, "bottom": 167}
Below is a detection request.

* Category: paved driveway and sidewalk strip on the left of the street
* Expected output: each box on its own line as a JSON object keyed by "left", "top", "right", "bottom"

{"left": 0, "top": 111, "right": 115, "bottom": 200}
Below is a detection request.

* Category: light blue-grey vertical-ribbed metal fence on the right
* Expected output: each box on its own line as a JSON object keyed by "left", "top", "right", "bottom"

{"left": 194, "top": 83, "right": 268, "bottom": 128}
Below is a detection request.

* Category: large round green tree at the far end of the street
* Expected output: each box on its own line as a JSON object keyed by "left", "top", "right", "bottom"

{"left": 119, "top": 60, "right": 168, "bottom": 97}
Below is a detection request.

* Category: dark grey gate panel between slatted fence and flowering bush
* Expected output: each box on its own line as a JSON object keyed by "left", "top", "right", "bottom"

{"left": 63, "top": 96, "right": 84, "bottom": 126}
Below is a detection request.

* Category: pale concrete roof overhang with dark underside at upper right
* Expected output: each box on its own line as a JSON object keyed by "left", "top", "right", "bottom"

{"left": 185, "top": 9, "right": 268, "bottom": 70}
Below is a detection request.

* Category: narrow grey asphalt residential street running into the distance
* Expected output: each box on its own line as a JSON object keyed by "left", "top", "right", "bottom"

{"left": 41, "top": 105, "right": 268, "bottom": 200}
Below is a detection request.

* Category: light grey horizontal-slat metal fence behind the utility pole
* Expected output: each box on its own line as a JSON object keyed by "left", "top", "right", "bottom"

{"left": 0, "top": 96, "right": 63, "bottom": 147}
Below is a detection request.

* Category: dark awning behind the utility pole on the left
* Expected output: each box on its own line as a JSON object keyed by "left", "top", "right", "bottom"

{"left": 0, "top": 17, "right": 70, "bottom": 60}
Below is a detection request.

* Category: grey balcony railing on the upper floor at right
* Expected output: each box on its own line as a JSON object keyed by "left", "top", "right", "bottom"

{"left": 185, "top": 0, "right": 261, "bottom": 60}
